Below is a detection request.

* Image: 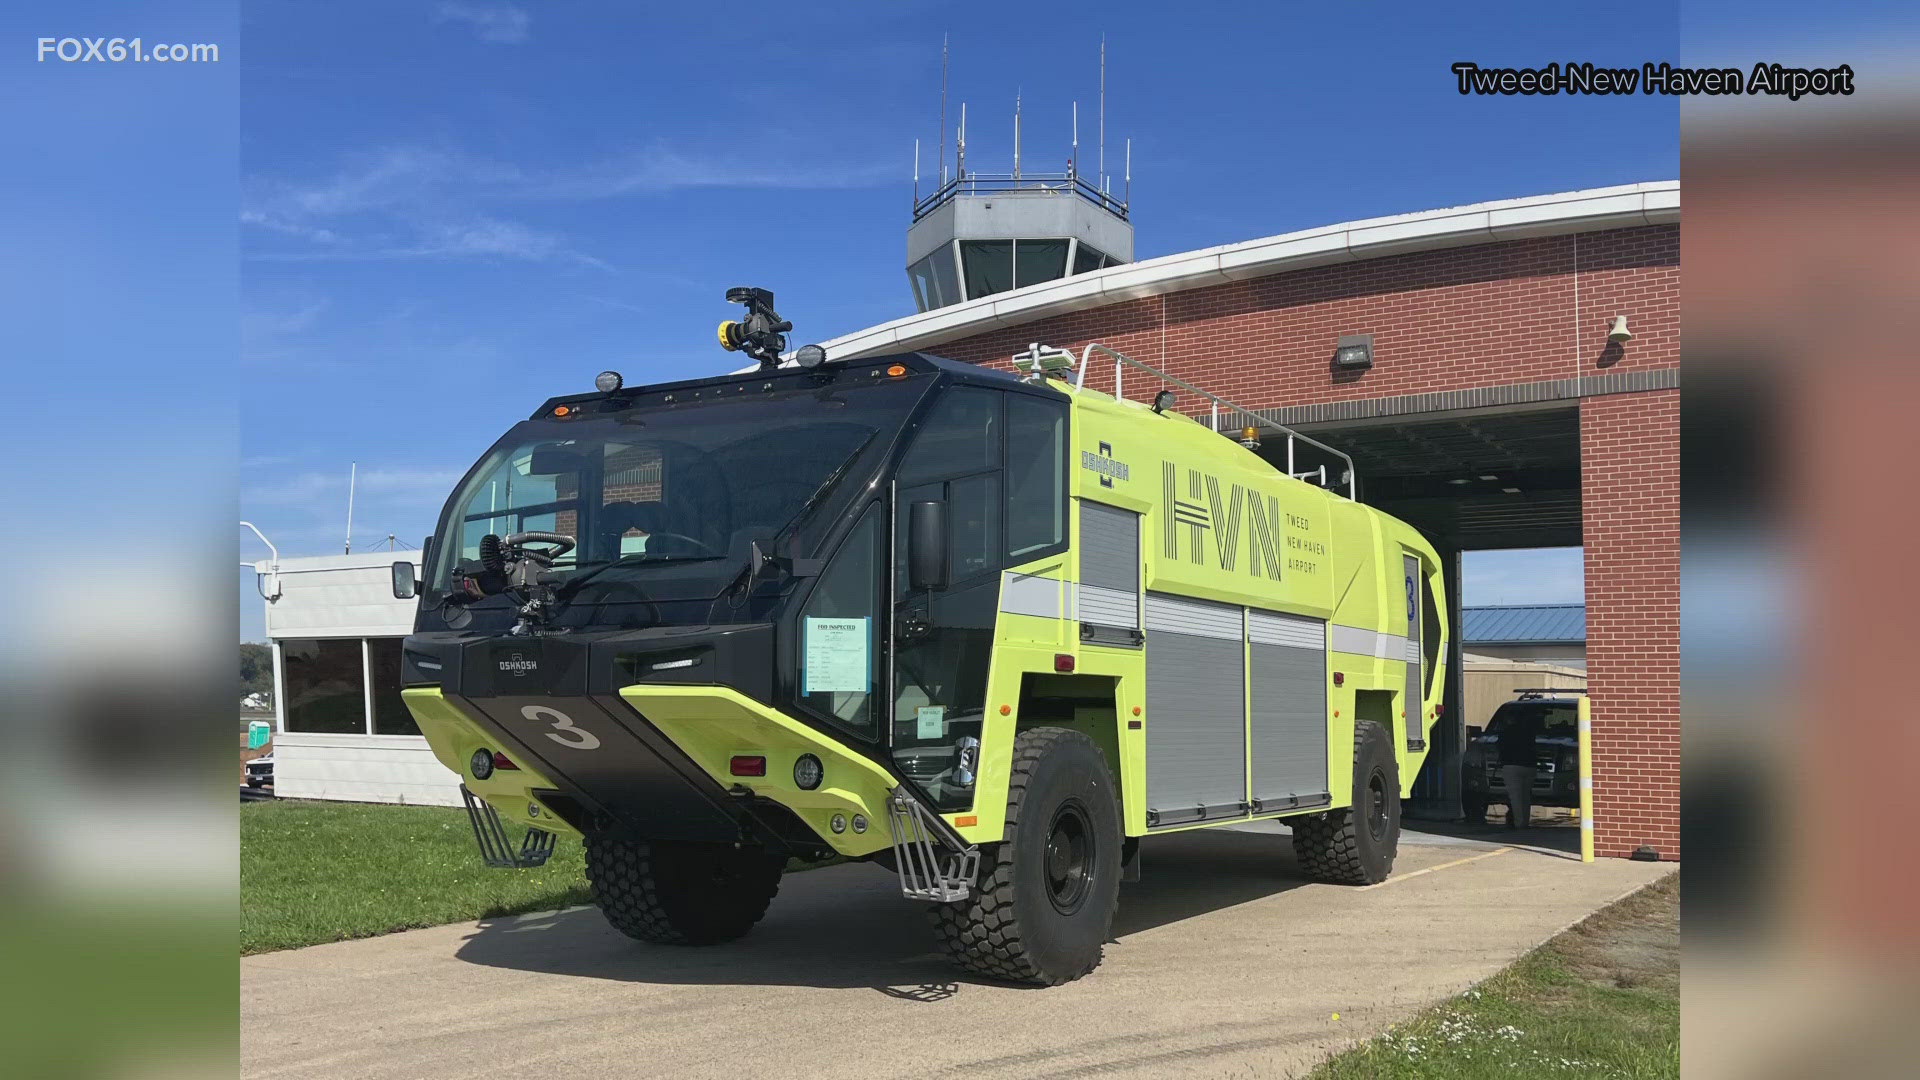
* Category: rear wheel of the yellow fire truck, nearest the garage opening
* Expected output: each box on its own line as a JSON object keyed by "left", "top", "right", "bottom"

{"left": 1288, "top": 721, "right": 1400, "bottom": 886}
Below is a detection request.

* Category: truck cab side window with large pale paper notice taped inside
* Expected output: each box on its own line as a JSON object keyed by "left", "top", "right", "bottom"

{"left": 799, "top": 505, "right": 881, "bottom": 738}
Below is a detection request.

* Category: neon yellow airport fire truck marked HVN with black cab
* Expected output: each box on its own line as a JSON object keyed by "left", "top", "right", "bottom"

{"left": 394, "top": 288, "right": 1448, "bottom": 984}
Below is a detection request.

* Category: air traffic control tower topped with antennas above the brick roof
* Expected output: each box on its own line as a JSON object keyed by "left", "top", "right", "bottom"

{"left": 906, "top": 94, "right": 1133, "bottom": 311}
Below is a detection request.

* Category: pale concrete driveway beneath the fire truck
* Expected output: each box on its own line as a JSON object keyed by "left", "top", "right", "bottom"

{"left": 240, "top": 826, "right": 1672, "bottom": 1080}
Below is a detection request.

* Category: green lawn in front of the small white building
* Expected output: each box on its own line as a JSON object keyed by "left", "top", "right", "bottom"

{"left": 240, "top": 799, "right": 588, "bottom": 955}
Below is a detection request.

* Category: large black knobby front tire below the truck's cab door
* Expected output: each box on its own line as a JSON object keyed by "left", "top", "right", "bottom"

{"left": 931, "top": 728, "right": 1121, "bottom": 986}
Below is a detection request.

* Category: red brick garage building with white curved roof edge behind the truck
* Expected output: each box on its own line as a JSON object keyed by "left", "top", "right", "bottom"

{"left": 826, "top": 183, "right": 1680, "bottom": 859}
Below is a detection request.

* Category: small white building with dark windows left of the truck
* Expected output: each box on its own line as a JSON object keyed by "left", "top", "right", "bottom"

{"left": 255, "top": 552, "right": 461, "bottom": 805}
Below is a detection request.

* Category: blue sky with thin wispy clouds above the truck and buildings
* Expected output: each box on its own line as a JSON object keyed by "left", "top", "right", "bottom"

{"left": 238, "top": 0, "right": 1678, "bottom": 638}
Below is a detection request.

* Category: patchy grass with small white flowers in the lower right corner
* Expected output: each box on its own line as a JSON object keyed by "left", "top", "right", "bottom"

{"left": 1309, "top": 874, "right": 1680, "bottom": 1080}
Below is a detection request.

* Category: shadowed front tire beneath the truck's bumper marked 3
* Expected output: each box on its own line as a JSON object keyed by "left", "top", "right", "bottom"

{"left": 586, "top": 836, "right": 783, "bottom": 945}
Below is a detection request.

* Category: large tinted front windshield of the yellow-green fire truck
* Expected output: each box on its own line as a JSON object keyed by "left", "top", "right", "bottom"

{"left": 432, "top": 379, "right": 924, "bottom": 588}
